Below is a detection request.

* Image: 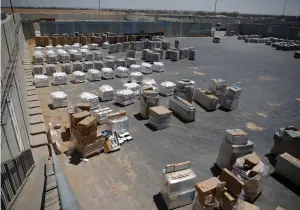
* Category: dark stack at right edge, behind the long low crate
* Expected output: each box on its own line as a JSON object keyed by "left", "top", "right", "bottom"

{"left": 271, "top": 126, "right": 300, "bottom": 159}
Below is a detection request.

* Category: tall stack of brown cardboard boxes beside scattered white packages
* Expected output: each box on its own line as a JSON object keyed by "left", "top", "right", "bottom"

{"left": 70, "top": 111, "right": 97, "bottom": 149}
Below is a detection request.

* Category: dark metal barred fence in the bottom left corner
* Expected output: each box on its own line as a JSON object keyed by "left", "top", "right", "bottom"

{"left": 1, "top": 149, "right": 34, "bottom": 210}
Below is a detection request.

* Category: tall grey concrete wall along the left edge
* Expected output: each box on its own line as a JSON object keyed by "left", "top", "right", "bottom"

{"left": 1, "top": 14, "right": 30, "bottom": 162}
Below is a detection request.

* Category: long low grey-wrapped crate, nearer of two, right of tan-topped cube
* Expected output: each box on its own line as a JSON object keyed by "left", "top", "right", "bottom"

{"left": 169, "top": 96, "right": 196, "bottom": 122}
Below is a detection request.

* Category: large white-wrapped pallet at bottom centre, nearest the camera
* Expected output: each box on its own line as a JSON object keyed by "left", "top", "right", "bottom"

{"left": 160, "top": 161, "right": 196, "bottom": 209}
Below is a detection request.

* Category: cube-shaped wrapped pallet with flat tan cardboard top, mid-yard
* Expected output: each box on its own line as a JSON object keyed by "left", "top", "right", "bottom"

{"left": 149, "top": 106, "right": 172, "bottom": 130}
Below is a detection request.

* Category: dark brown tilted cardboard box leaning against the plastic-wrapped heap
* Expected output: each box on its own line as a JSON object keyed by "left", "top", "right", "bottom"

{"left": 219, "top": 168, "right": 244, "bottom": 196}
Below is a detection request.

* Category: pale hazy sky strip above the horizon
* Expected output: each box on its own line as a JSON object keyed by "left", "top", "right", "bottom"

{"left": 2, "top": 0, "right": 300, "bottom": 15}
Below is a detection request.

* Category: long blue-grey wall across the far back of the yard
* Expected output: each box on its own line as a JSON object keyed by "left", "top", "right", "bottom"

{"left": 40, "top": 21, "right": 212, "bottom": 36}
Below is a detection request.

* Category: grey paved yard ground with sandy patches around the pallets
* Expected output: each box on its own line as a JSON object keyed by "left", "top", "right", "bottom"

{"left": 32, "top": 37, "right": 300, "bottom": 210}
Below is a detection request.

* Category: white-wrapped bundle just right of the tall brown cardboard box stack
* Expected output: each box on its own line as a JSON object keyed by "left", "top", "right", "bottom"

{"left": 106, "top": 111, "right": 129, "bottom": 133}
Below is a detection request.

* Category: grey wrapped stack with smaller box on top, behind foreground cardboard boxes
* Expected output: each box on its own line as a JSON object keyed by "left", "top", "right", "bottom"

{"left": 215, "top": 129, "right": 254, "bottom": 169}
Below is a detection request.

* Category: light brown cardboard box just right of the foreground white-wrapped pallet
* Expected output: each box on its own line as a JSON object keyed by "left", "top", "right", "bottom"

{"left": 196, "top": 177, "right": 221, "bottom": 205}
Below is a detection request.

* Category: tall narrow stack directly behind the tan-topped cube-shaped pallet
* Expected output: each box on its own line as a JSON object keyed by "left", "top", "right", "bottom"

{"left": 140, "top": 85, "right": 159, "bottom": 119}
